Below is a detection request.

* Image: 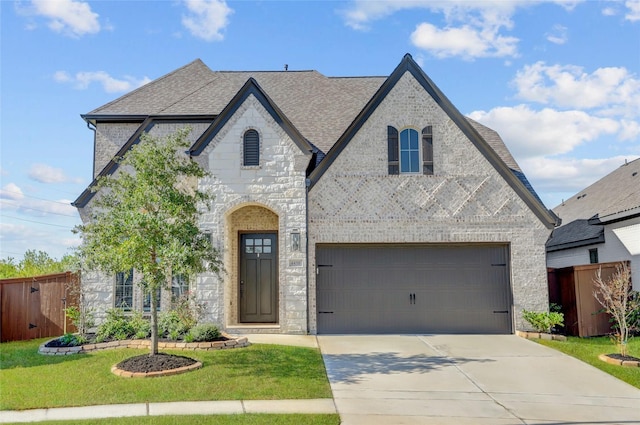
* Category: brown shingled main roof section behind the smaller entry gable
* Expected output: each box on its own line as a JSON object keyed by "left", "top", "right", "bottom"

{"left": 83, "top": 59, "right": 386, "bottom": 152}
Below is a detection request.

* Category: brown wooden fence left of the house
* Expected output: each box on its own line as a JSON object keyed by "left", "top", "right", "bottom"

{"left": 0, "top": 272, "right": 80, "bottom": 342}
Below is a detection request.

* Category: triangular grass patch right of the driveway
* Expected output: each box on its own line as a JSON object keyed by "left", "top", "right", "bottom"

{"left": 536, "top": 337, "right": 640, "bottom": 388}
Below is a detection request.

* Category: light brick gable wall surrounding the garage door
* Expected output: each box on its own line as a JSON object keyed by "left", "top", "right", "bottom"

{"left": 309, "top": 73, "right": 551, "bottom": 332}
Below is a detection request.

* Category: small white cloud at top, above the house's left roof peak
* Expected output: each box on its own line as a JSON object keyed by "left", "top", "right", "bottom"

{"left": 182, "top": 0, "right": 233, "bottom": 41}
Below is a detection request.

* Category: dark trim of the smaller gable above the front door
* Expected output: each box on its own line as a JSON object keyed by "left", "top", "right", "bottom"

{"left": 189, "top": 78, "right": 314, "bottom": 156}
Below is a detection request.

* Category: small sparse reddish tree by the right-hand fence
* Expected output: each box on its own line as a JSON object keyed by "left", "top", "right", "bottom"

{"left": 593, "top": 262, "right": 640, "bottom": 356}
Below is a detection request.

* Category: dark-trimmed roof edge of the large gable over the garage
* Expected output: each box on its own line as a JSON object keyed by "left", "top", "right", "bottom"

{"left": 309, "top": 53, "right": 557, "bottom": 228}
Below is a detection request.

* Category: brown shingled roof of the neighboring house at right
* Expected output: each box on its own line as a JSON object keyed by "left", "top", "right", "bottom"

{"left": 553, "top": 158, "right": 640, "bottom": 224}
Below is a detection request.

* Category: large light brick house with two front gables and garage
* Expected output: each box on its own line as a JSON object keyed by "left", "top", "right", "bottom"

{"left": 74, "top": 55, "right": 556, "bottom": 334}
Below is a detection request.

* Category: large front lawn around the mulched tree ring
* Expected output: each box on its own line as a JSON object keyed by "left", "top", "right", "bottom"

{"left": 0, "top": 340, "right": 331, "bottom": 410}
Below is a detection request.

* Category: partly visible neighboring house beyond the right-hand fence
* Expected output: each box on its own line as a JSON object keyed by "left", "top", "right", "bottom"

{"left": 547, "top": 159, "right": 640, "bottom": 290}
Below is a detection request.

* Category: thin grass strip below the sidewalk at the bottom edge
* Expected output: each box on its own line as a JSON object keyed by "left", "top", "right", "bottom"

{"left": 3, "top": 414, "right": 340, "bottom": 425}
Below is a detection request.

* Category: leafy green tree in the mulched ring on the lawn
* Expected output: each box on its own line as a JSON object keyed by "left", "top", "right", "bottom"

{"left": 76, "top": 129, "right": 220, "bottom": 355}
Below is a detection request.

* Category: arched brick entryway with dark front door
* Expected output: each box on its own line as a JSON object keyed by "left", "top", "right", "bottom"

{"left": 227, "top": 205, "right": 279, "bottom": 324}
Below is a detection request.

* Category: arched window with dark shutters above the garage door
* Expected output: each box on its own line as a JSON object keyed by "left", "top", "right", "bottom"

{"left": 387, "top": 126, "right": 433, "bottom": 175}
